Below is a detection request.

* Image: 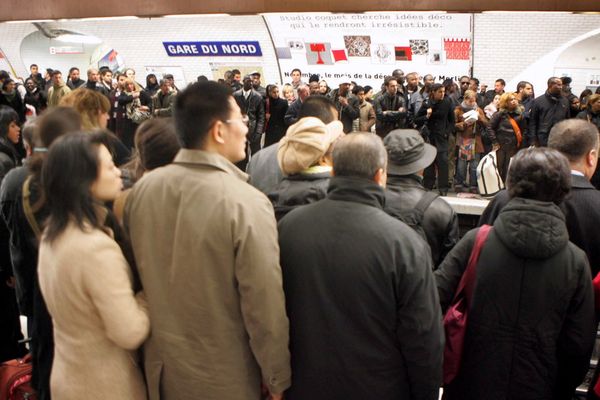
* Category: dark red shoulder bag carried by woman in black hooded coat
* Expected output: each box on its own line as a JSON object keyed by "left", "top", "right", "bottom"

{"left": 443, "top": 225, "right": 492, "bottom": 385}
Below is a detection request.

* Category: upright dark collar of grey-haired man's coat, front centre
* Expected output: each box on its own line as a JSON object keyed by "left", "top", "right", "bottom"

{"left": 327, "top": 176, "right": 385, "bottom": 209}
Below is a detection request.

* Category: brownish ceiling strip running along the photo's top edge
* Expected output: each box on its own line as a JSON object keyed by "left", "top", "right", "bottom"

{"left": 0, "top": 0, "right": 600, "bottom": 21}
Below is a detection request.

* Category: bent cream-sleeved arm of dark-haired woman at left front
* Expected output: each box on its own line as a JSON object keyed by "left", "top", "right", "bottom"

{"left": 83, "top": 235, "right": 150, "bottom": 350}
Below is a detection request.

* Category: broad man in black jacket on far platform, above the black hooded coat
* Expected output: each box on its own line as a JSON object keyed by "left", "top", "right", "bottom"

{"left": 529, "top": 77, "right": 570, "bottom": 146}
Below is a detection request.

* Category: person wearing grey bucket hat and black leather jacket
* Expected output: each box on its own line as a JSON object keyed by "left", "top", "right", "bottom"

{"left": 383, "top": 129, "right": 459, "bottom": 267}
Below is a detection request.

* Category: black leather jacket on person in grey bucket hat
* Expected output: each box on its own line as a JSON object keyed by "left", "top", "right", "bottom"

{"left": 384, "top": 175, "right": 460, "bottom": 267}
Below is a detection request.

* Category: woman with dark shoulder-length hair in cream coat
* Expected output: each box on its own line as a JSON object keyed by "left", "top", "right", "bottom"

{"left": 38, "top": 133, "right": 150, "bottom": 400}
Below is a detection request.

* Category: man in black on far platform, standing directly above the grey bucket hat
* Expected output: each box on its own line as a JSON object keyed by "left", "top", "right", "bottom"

{"left": 415, "top": 83, "right": 454, "bottom": 196}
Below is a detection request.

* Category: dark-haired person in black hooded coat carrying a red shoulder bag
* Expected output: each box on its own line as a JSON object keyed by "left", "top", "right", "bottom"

{"left": 435, "top": 147, "right": 596, "bottom": 400}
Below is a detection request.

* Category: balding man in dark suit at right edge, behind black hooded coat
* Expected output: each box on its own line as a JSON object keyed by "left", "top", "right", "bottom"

{"left": 479, "top": 119, "right": 600, "bottom": 277}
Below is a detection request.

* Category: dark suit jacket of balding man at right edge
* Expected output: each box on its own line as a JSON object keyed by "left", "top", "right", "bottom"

{"left": 479, "top": 175, "right": 600, "bottom": 277}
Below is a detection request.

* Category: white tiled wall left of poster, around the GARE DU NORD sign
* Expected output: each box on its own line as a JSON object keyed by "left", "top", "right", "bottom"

{"left": 0, "top": 16, "right": 280, "bottom": 82}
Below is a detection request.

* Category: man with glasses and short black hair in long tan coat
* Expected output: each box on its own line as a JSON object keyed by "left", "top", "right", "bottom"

{"left": 124, "top": 82, "right": 291, "bottom": 400}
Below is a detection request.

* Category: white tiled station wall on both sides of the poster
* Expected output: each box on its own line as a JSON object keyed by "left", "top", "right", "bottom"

{"left": 0, "top": 13, "right": 600, "bottom": 94}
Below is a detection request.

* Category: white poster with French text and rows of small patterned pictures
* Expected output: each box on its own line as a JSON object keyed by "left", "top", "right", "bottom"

{"left": 264, "top": 12, "right": 472, "bottom": 88}
